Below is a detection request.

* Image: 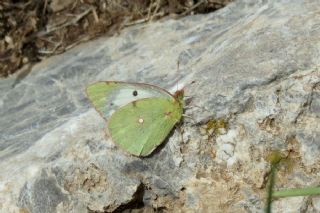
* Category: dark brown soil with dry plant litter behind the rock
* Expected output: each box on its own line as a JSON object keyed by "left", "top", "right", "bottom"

{"left": 0, "top": 0, "right": 232, "bottom": 77}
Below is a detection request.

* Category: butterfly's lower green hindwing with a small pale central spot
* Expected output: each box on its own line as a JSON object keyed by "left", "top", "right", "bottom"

{"left": 108, "top": 98, "right": 183, "bottom": 156}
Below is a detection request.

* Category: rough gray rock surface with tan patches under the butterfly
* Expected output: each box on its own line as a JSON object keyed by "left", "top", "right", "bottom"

{"left": 0, "top": 0, "right": 320, "bottom": 213}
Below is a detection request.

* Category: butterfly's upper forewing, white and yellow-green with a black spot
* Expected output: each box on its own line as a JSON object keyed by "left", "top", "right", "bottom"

{"left": 86, "top": 81, "right": 174, "bottom": 120}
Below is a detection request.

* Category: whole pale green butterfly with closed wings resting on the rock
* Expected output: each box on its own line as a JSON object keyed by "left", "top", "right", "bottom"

{"left": 86, "top": 81, "right": 184, "bottom": 156}
